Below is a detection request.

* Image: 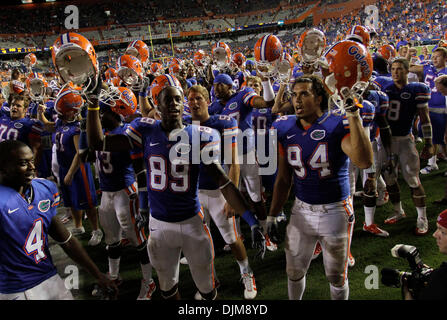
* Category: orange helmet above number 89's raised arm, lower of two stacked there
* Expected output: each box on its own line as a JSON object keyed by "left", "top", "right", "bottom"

{"left": 116, "top": 54, "right": 143, "bottom": 91}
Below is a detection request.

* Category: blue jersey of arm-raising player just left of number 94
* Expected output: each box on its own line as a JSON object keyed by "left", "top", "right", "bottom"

{"left": 220, "top": 87, "right": 258, "bottom": 154}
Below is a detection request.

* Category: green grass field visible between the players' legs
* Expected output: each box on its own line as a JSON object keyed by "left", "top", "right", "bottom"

{"left": 51, "top": 139, "right": 447, "bottom": 300}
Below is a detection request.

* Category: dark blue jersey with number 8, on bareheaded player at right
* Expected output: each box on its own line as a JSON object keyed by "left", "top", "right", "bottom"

{"left": 383, "top": 82, "right": 430, "bottom": 136}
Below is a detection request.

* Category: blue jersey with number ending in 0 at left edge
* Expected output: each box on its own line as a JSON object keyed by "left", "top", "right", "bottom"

{"left": 0, "top": 117, "right": 43, "bottom": 145}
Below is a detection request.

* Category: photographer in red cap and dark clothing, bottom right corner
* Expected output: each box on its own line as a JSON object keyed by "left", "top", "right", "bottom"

{"left": 402, "top": 210, "right": 447, "bottom": 300}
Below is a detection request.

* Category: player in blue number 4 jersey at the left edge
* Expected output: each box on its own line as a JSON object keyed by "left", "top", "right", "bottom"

{"left": 0, "top": 140, "right": 118, "bottom": 300}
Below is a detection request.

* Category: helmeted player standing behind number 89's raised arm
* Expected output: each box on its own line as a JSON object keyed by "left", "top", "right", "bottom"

{"left": 96, "top": 87, "right": 155, "bottom": 300}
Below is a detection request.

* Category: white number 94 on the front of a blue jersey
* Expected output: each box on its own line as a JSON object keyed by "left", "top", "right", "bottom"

{"left": 287, "top": 143, "right": 331, "bottom": 179}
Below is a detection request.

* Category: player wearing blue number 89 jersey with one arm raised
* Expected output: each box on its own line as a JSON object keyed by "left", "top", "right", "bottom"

{"left": 87, "top": 78, "right": 265, "bottom": 299}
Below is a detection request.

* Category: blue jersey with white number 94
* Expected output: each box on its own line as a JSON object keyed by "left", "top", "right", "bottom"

{"left": 273, "top": 113, "right": 350, "bottom": 204}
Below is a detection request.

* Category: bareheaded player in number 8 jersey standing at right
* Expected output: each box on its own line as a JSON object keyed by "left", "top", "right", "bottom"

{"left": 379, "top": 58, "right": 434, "bottom": 235}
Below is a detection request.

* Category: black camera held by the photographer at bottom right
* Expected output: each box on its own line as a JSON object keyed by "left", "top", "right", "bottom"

{"left": 381, "top": 244, "right": 433, "bottom": 300}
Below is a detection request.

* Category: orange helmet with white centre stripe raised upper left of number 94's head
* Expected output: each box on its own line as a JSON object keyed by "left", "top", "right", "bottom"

{"left": 254, "top": 34, "right": 283, "bottom": 78}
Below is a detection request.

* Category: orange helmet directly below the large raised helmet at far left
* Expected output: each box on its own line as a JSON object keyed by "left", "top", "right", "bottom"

{"left": 54, "top": 82, "right": 85, "bottom": 122}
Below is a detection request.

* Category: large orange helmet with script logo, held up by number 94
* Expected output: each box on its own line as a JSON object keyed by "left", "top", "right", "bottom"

{"left": 324, "top": 40, "right": 373, "bottom": 109}
